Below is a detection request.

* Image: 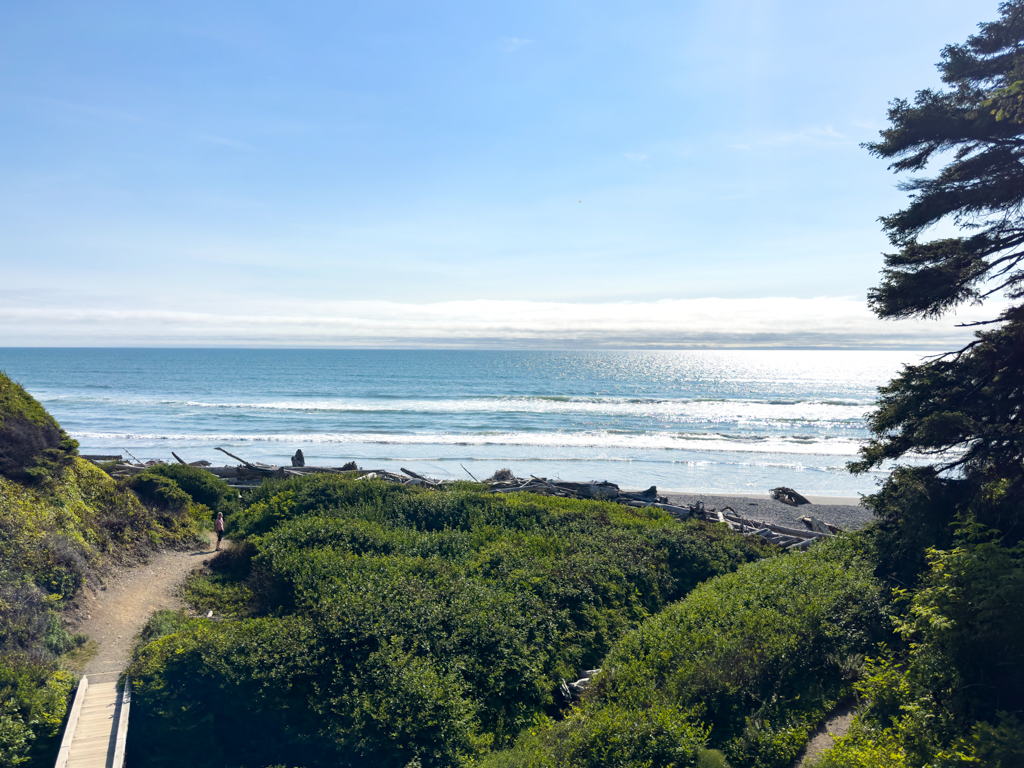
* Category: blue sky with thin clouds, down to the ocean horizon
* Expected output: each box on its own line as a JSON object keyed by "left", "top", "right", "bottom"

{"left": 0, "top": 0, "right": 997, "bottom": 347}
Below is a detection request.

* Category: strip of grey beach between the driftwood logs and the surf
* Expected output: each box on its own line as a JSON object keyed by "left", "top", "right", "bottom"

{"left": 662, "top": 490, "right": 872, "bottom": 530}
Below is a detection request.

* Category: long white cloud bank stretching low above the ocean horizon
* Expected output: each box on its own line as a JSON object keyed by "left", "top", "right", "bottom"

{"left": 0, "top": 297, "right": 991, "bottom": 349}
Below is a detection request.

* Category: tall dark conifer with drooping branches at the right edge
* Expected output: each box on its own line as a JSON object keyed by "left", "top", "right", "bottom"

{"left": 851, "top": 0, "right": 1024, "bottom": 572}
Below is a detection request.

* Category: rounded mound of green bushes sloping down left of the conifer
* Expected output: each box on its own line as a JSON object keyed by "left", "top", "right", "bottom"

{"left": 487, "top": 538, "right": 887, "bottom": 768}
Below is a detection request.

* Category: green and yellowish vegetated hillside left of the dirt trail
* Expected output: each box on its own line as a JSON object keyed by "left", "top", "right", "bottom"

{"left": 0, "top": 374, "right": 209, "bottom": 767}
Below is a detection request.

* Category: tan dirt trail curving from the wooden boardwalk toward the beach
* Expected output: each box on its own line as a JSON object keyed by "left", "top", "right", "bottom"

{"left": 69, "top": 536, "right": 227, "bottom": 675}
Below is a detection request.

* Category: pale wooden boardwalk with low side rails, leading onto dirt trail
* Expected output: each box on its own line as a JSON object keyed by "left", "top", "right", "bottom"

{"left": 55, "top": 675, "right": 131, "bottom": 768}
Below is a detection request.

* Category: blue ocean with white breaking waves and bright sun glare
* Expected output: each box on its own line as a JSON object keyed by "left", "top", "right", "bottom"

{"left": 0, "top": 348, "right": 923, "bottom": 497}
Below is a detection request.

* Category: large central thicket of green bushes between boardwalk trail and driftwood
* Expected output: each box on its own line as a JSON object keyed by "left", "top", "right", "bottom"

{"left": 123, "top": 475, "right": 773, "bottom": 767}
